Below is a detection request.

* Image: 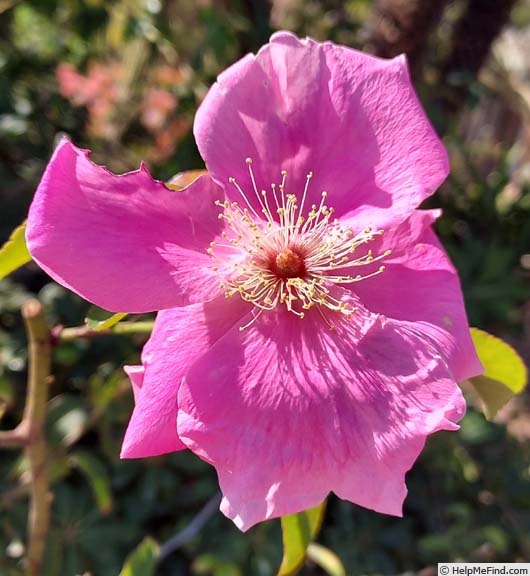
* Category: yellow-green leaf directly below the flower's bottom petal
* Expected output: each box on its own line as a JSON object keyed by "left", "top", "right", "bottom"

{"left": 278, "top": 502, "right": 326, "bottom": 576}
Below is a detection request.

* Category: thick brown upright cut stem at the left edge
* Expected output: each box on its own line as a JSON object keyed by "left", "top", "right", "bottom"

{"left": 0, "top": 300, "right": 51, "bottom": 576}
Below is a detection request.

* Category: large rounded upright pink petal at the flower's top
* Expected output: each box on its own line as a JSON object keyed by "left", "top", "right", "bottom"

{"left": 194, "top": 33, "right": 448, "bottom": 227}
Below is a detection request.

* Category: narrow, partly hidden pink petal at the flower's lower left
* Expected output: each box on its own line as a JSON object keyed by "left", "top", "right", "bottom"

{"left": 121, "top": 296, "right": 248, "bottom": 458}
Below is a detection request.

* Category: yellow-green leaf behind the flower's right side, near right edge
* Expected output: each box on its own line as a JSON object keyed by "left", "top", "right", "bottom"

{"left": 469, "top": 328, "right": 528, "bottom": 420}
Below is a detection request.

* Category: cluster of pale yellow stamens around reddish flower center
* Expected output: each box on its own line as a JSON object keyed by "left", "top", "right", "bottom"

{"left": 208, "top": 158, "right": 390, "bottom": 330}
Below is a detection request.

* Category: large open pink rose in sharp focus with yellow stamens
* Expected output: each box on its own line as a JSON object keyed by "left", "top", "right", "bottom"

{"left": 27, "top": 33, "right": 481, "bottom": 529}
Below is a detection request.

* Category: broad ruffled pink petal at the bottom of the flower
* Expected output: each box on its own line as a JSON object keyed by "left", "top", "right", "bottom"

{"left": 177, "top": 310, "right": 465, "bottom": 530}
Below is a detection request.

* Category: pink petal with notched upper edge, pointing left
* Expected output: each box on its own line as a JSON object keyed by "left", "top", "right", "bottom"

{"left": 26, "top": 139, "right": 222, "bottom": 312}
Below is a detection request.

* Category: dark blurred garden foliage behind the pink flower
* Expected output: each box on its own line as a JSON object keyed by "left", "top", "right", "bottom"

{"left": 0, "top": 0, "right": 530, "bottom": 576}
